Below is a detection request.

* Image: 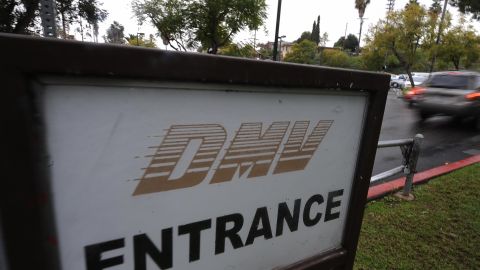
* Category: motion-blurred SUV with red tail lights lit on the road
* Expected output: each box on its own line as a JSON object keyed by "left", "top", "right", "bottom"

{"left": 406, "top": 71, "right": 480, "bottom": 130}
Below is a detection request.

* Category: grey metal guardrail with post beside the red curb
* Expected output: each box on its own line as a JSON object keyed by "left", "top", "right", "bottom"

{"left": 370, "top": 134, "right": 423, "bottom": 196}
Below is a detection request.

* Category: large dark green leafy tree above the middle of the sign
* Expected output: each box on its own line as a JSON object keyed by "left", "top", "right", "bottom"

{"left": 132, "top": 0, "right": 266, "bottom": 54}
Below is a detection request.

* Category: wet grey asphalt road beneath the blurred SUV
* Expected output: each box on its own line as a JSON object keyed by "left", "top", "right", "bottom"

{"left": 373, "top": 90, "right": 480, "bottom": 178}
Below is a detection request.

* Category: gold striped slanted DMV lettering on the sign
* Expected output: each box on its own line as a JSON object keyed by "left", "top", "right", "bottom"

{"left": 133, "top": 120, "right": 333, "bottom": 196}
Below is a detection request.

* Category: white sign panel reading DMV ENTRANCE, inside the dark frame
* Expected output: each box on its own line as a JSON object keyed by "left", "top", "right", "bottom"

{"left": 42, "top": 80, "right": 367, "bottom": 270}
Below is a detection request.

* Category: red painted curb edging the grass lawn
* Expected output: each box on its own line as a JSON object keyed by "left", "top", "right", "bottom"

{"left": 367, "top": 155, "right": 480, "bottom": 200}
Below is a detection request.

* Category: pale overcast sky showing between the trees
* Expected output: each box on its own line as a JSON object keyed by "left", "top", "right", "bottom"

{"left": 100, "top": 0, "right": 480, "bottom": 47}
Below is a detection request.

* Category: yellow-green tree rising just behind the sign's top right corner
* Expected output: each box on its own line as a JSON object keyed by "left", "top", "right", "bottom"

{"left": 367, "top": 3, "right": 427, "bottom": 86}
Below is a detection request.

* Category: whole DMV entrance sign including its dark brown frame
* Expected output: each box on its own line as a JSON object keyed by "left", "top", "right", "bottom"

{"left": 0, "top": 35, "right": 388, "bottom": 270}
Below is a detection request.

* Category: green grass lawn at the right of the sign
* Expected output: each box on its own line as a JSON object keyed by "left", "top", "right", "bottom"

{"left": 354, "top": 164, "right": 480, "bottom": 270}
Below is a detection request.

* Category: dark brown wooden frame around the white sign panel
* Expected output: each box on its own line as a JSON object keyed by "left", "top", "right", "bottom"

{"left": 0, "top": 34, "right": 390, "bottom": 270}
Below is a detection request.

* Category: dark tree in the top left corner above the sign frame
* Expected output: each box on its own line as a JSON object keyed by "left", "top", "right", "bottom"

{"left": 0, "top": 0, "right": 40, "bottom": 34}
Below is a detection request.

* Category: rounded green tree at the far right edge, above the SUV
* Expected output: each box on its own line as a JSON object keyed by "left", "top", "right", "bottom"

{"left": 438, "top": 20, "right": 480, "bottom": 70}
